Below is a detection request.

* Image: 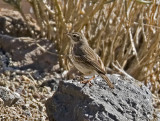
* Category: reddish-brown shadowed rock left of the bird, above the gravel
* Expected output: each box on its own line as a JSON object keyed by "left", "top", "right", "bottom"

{"left": 0, "top": 34, "right": 58, "bottom": 71}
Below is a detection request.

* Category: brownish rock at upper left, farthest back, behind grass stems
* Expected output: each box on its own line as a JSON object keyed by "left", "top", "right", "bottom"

{"left": 0, "top": 8, "right": 40, "bottom": 37}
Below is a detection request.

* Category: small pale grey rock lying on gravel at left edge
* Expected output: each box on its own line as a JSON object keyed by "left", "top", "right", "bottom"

{"left": 0, "top": 86, "right": 20, "bottom": 106}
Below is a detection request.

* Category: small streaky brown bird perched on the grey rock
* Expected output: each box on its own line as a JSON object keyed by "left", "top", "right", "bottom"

{"left": 67, "top": 32, "right": 114, "bottom": 88}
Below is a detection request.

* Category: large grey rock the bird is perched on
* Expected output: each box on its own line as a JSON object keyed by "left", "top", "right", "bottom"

{"left": 46, "top": 75, "right": 153, "bottom": 121}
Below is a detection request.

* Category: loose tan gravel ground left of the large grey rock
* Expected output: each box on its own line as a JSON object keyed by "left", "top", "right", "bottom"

{"left": 0, "top": 51, "right": 60, "bottom": 121}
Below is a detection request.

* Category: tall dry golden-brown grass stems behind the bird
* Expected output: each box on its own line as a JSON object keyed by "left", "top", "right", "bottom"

{"left": 4, "top": 0, "right": 160, "bottom": 107}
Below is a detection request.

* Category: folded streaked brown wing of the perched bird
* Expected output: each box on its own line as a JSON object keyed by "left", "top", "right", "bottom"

{"left": 79, "top": 46, "right": 106, "bottom": 74}
